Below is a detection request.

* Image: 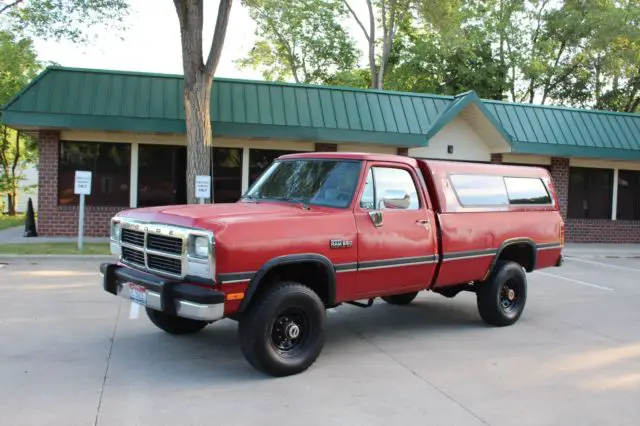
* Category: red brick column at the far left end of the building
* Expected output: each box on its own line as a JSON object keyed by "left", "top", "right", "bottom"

{"left": 36, "top": 130, "right": 60, "bottom": 236}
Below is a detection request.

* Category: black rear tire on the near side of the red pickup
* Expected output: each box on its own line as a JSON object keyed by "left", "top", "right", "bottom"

{"left": 476, "top": 260, "right": 527, "bottom": 327}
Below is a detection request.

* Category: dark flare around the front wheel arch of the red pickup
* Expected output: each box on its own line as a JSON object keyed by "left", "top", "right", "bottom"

{"left": 238, "top": 253, "right": 336, "bottom": 312}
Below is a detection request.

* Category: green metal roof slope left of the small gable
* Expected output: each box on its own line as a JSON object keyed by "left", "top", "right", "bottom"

{"left": 3, "top": 67, "right": 450, "bottom": 146}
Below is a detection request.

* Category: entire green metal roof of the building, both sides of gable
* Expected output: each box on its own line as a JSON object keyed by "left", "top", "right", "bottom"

{"left": 2, "top": 67, "right": 640, "bottom": 160}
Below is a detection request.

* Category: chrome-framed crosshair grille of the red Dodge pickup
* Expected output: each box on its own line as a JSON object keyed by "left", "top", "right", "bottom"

{"left": 120, "top": 228, "right": 184, "bottom": 277}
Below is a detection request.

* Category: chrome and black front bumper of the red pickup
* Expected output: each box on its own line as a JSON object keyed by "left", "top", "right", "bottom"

{"left": 100, "top": 263, "right": 224, "bottom": 321}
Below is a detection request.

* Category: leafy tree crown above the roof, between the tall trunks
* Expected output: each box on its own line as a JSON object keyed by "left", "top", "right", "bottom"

{"left": 237, "top": 0, "right": 358, "bottom": 83}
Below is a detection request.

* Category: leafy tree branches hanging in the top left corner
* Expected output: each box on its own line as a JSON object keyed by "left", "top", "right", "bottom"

{"left": 0, "top": 0, "right": 129, "bottom": 42}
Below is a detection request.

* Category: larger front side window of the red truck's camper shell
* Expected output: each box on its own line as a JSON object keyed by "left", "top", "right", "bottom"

{"left": 450, "top": 175, "right": 509, "bottom": 206}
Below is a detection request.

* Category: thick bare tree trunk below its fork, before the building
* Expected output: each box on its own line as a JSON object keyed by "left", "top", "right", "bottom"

{"left": 184, "top": 73, "right": 213, "bottom": 204}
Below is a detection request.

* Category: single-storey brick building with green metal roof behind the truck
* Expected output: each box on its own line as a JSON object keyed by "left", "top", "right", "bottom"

{"left": 2, "top": 67, "right": 640, "bottom": 243}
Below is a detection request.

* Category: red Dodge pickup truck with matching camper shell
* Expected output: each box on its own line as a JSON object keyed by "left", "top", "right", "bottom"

{"left": 100, "top": 153, "right": 564, "bottom": 376}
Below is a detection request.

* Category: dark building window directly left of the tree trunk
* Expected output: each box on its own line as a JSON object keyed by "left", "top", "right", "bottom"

{"left": 138, "top": 145, "right": 187, "bottom": 207}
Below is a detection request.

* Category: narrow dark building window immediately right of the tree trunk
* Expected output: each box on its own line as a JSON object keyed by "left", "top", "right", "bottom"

{"left": 212, "top": 147, "right": 242, "bottom": 203}
